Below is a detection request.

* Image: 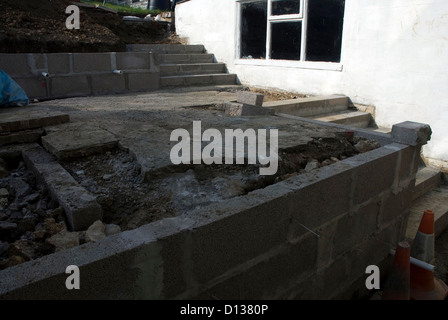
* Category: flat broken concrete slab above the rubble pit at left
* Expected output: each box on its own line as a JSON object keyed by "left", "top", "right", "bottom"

{"left": 42, "top": 127, "right": 118, "bottom": 159}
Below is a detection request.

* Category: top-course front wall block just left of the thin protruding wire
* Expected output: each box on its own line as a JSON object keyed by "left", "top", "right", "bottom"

{"left": 190, "top": 198, "right": 290, "bottom": 283}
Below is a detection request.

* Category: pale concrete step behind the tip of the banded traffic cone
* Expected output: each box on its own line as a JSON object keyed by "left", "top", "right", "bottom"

{"left": 406, "top": 185, "right": 448, "bottom": 240}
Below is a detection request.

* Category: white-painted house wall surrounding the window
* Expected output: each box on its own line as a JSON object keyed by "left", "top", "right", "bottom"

{"left": 176, "top": 0, "right": 448, "bottom": 163}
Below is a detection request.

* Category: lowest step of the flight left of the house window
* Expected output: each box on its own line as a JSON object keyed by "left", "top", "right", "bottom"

{"left": 160, "top": 73, "right": 236, "bottom": 87}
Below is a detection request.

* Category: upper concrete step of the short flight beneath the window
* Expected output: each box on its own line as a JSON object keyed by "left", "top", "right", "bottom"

{"left": 263, "top": 95, "right": 348, "bottom": 117}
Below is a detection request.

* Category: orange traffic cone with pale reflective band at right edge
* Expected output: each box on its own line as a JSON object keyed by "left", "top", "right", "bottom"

{"left": 411, "top": 210, "right": 448, "bottom": 300}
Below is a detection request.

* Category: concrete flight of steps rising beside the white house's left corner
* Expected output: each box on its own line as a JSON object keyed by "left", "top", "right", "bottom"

{"left": 126, "top": 44, "right": 237, "bottom": 87}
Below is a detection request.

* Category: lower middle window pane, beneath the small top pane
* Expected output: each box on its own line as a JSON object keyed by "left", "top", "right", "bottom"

{"left": 271, "top": 22, "right": 302, "bottom": 60}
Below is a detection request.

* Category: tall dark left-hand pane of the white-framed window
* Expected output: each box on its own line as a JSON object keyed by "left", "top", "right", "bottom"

{"left": 240, "top": 0, "right": 268, "bottom": 59}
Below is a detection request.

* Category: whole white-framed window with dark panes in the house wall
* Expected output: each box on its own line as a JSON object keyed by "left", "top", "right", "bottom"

{"left": 238, "top": 0, "right": 345, "bottom": 62}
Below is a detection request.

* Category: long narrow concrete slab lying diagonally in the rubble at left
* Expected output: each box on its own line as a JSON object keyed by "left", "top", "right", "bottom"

{"left": 22, "top": 144, "right": 102, "bottom": 231}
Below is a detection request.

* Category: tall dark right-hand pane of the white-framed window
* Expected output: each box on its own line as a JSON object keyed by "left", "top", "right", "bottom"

{"left": 306, "top": 0, "right": 345, "bottom": 62}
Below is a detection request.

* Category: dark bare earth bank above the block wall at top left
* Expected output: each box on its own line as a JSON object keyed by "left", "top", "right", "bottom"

{"left": 0, "top": 0, "right": 181, "bottom": 53}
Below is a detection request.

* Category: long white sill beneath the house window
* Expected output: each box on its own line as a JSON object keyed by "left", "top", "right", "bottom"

{"left": 235, "top": 59, "right": 343, "bottom": 71}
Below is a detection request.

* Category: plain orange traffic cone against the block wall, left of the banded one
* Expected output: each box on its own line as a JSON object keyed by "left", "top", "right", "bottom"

{"left": 382, "top": 241, "right": 411, "bottom": 300}
